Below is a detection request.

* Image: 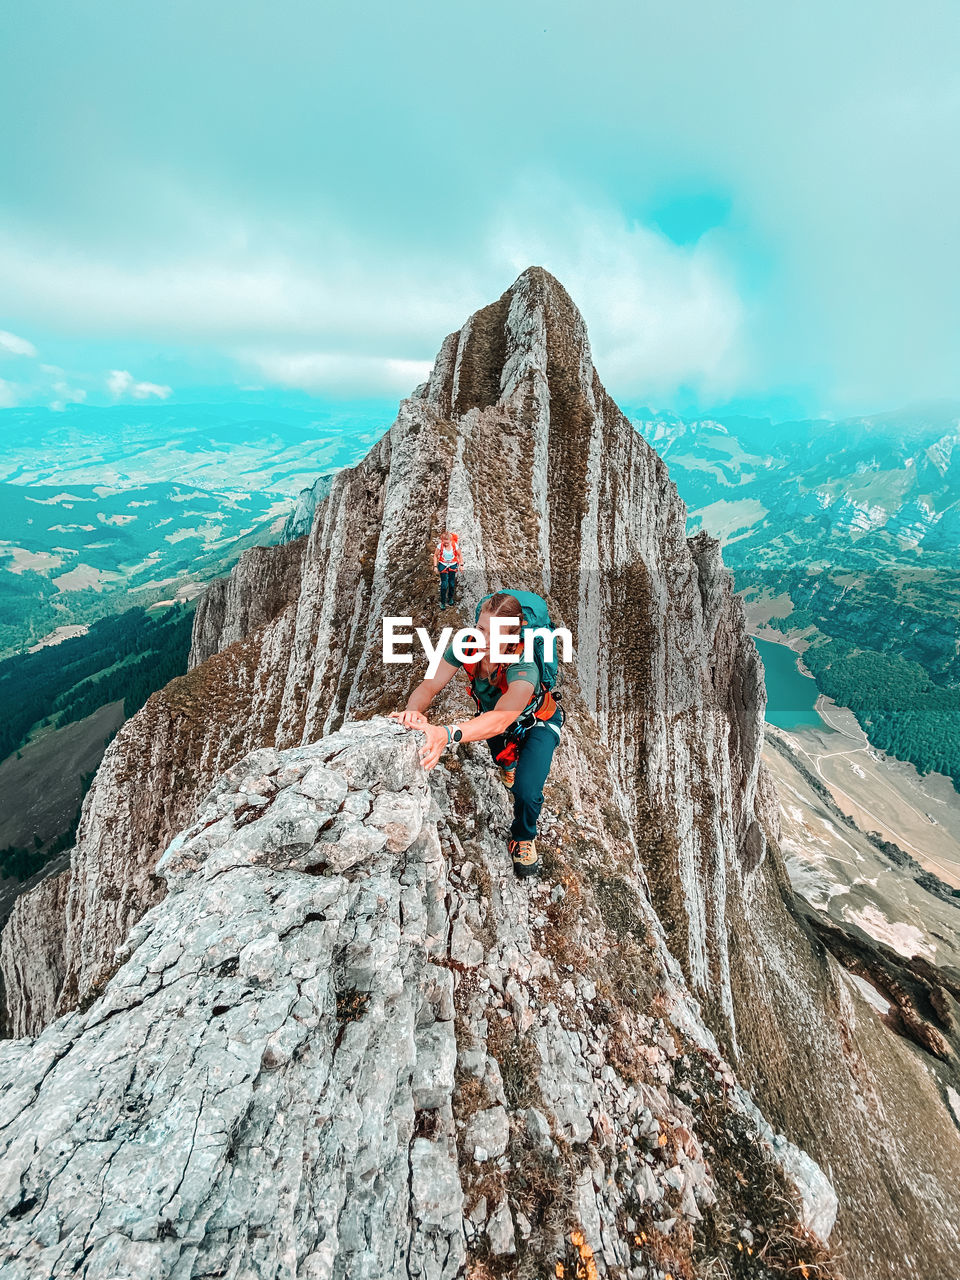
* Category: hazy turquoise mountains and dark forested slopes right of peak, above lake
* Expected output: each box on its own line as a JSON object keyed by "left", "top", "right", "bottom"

{"left": 639, "top": 406, "right": 960, "bottom": 787}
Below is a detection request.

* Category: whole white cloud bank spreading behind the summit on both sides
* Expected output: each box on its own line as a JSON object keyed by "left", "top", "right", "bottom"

{"left": 0, "top": 194, "right": 748, "bottom": 399}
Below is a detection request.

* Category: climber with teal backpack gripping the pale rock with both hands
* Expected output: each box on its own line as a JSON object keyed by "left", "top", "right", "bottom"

{"left": 392, "top": 591, "right": 563, "bottom": 878}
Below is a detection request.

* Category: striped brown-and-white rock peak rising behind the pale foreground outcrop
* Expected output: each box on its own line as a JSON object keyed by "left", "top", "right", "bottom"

{"left": 4, "top": 269, "right": 960, "bottom": 1280}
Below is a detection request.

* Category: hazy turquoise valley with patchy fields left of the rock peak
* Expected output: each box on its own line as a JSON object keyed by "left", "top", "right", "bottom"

{"left": 0, "top": 402, "right": 389, "bottom": 657}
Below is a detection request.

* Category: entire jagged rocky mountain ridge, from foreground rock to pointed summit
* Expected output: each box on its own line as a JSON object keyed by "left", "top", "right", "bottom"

{"left": 0, "top": 268, "right": 960, "bottom": 1280}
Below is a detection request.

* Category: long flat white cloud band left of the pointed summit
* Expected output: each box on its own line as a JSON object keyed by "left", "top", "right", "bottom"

{"left": 0, "top": 222, "right": 468, "bottom": 355}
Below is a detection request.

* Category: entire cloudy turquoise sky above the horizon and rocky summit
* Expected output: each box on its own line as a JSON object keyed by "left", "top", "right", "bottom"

{"left": 0, "top": 0, "right": 960, "bottom": 417}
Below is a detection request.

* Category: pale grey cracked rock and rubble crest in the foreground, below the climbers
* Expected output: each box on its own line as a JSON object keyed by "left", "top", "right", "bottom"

{"left": 0, "top": 721, "right": 836, "bottom": 1280}
